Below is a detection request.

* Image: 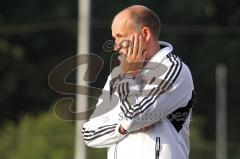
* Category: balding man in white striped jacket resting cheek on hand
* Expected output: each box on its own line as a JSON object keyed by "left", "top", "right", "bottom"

{"left": 83, "top": 5, "right": 194, "bottom": 159}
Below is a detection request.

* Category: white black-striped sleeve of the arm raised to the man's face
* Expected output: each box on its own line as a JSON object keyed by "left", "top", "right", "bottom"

{"left": 118, "top": 56, "right": 193, "bottom": 132}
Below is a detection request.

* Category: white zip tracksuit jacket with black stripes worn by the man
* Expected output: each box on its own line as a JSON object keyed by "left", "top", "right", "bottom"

{"left": 82, "top": 42, "right": 194, "bottom": 159}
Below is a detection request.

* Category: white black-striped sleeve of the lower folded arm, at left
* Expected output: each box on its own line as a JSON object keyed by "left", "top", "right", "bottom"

{"left": 82, "top": 73, "right": 124, "bottom": 148}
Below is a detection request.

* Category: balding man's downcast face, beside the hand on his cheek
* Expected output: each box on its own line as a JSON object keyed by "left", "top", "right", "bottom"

{"left": 112, "top": 14, "right": 136, "bottom": 55}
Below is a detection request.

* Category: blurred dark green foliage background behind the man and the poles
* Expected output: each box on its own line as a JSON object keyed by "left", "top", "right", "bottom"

{"left": 0, "top": 0, "right": 240, "bottom": 159}
